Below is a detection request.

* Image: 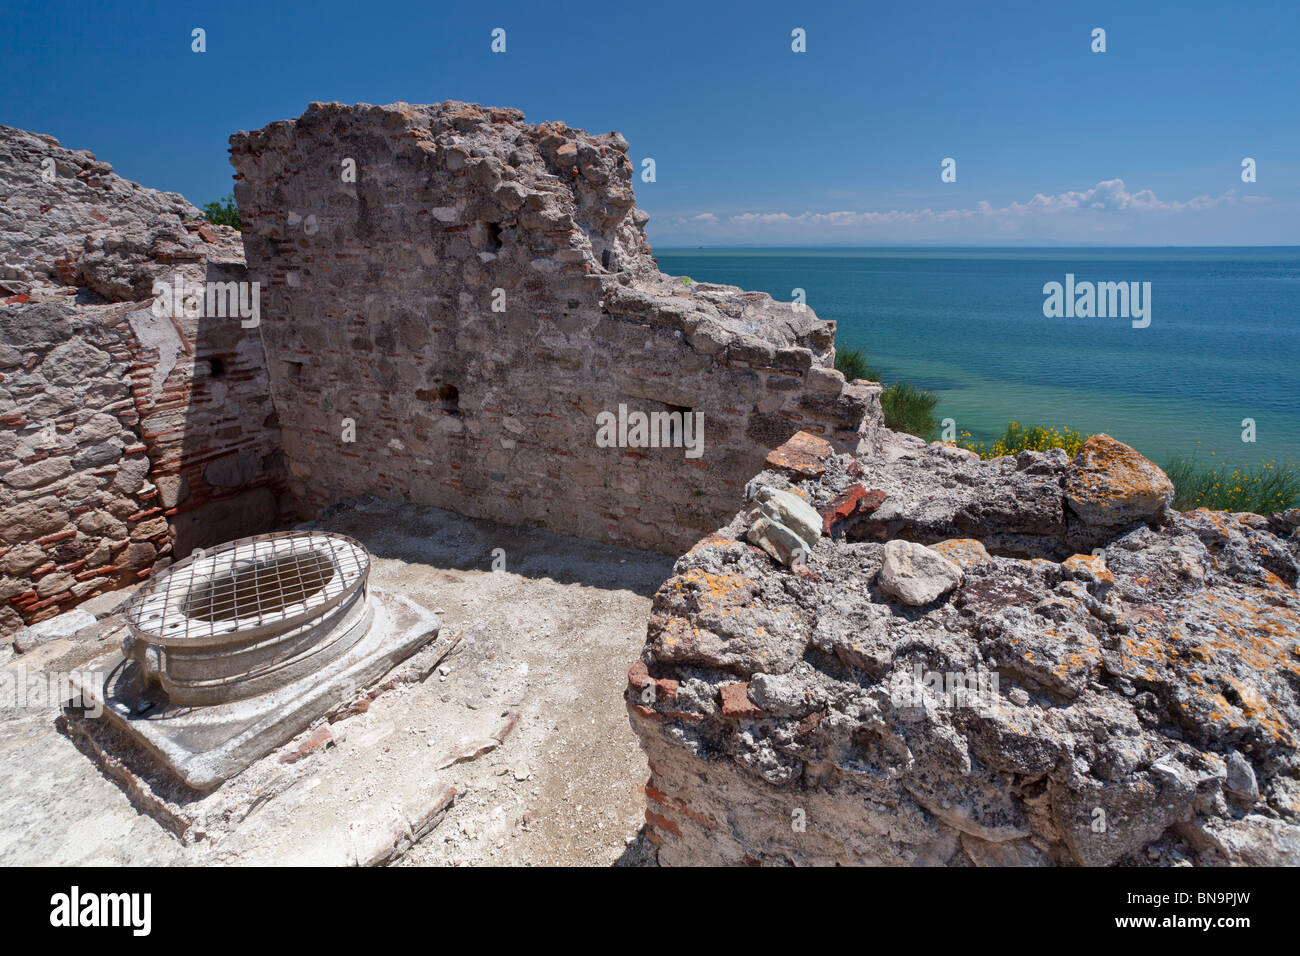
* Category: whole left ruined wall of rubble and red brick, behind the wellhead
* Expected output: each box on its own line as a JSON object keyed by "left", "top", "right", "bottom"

{"left": 0, "top": 126, "right": 282, "bottom": 635}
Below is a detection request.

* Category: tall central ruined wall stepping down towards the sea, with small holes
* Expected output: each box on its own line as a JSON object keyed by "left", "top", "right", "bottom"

{"left": 231, "top": 103, "right": 879, "bottom": 551}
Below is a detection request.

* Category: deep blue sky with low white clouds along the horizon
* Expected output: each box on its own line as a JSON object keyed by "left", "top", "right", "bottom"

{"left": 0, "top": 0, "right": 1300, "bottom": 247}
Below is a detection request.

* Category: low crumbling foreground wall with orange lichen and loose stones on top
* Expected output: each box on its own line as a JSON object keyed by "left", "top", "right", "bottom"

{"left": 627, "top": 436, "right": 1300, "bottom": 866}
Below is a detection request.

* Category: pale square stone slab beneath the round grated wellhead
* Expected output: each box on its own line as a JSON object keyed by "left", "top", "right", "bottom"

{"left": 69, "top": 587, "right": 441, "bottom": 792}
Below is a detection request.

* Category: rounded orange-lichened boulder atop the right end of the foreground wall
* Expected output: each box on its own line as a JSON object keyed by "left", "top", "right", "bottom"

{"left": 1065, "top": 434, "right": 1174, "bottom": 527}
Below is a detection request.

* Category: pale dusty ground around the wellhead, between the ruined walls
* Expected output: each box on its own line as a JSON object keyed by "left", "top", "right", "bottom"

{"left": 0, "top": 503, "right": 672, "bottom": 866}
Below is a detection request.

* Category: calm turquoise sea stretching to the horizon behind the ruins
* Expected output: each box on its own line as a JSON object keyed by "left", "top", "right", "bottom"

{"left": 658, "top": 247, "right": 1300, "bottom": 466}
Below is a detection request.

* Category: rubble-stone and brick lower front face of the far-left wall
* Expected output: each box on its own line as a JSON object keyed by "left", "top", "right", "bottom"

{"left": 0, "top": 303, "right": 159, "bottom": 631}
